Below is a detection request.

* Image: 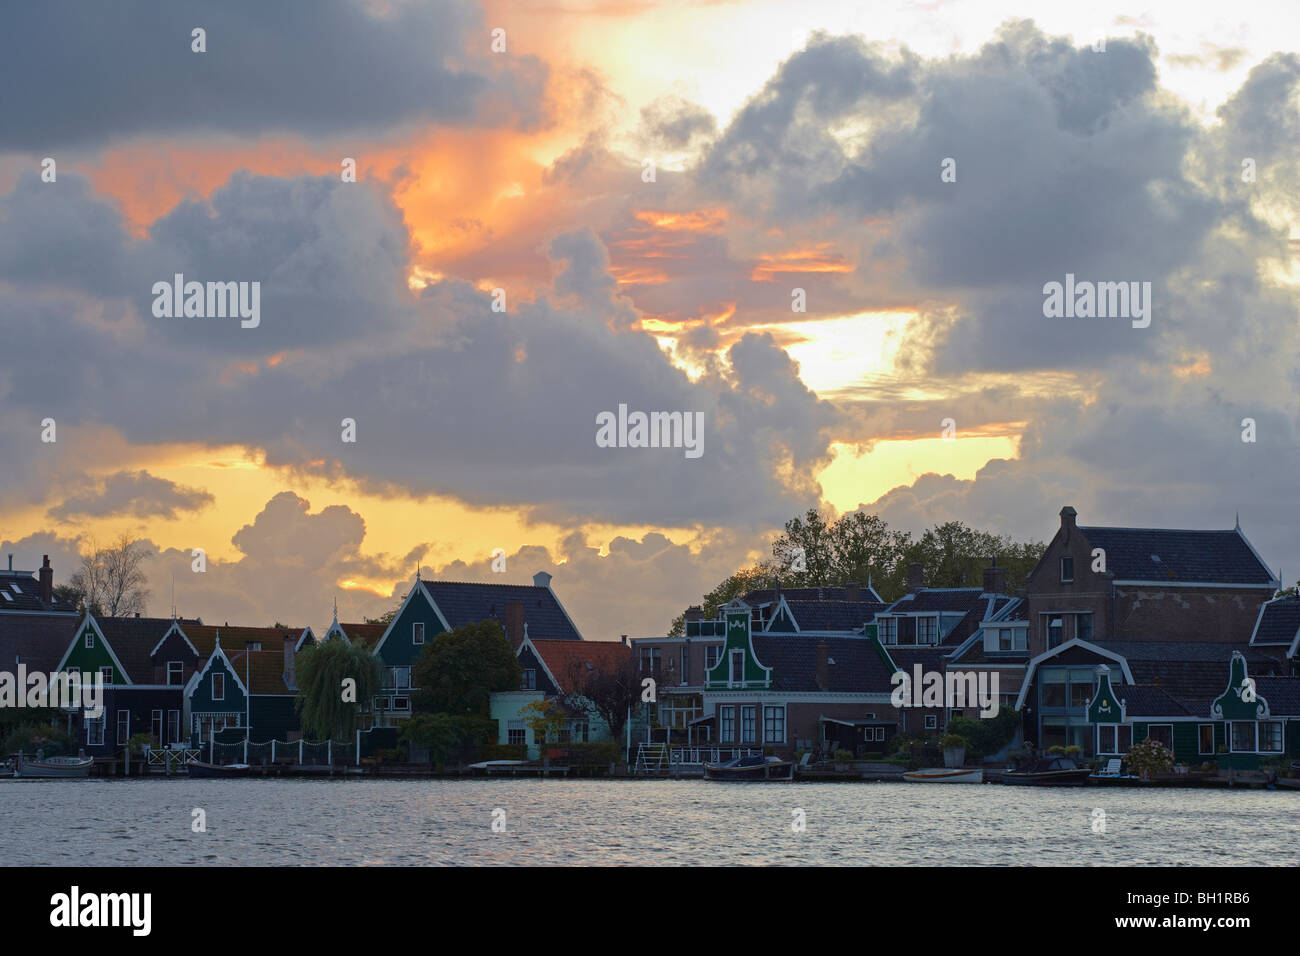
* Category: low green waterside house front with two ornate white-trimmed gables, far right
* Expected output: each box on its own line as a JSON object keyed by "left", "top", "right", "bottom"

{"left": 1088, "top": 650, "right": 1300, "bottom": 770}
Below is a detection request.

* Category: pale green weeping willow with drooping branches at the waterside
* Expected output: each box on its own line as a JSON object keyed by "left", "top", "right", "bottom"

{"left": 294, "top": 637, "right": 380, "bottom": 740}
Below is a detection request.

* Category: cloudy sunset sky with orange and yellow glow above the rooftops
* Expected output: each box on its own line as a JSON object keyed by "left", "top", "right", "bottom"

{"left": 0, "top": 0, "right": 1300, "bottom": 640}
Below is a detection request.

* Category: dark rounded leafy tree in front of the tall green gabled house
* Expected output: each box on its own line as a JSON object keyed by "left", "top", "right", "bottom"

{"left": 411, "top": 620, "right": 524, "bottom": 717}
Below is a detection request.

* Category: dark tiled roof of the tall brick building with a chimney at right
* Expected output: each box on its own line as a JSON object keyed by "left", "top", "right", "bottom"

{"left": 1079, "top": 525, "right": 1273, "bottom": 588}
